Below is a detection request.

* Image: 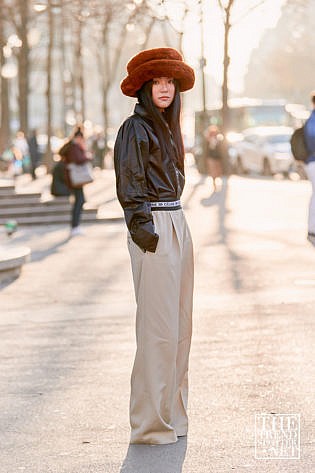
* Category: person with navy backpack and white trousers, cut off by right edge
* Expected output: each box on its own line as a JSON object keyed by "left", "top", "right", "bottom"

{"left": 304, "top": 91, "right": 315, "bottom": 246}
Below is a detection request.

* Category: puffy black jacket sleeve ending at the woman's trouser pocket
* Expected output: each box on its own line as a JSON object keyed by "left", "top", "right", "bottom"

{"left": 114, "top": 118, "right": 159, "bottom": 253}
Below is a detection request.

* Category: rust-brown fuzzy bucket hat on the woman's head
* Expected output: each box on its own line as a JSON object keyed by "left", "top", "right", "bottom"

{"left": 120, "top": 48, "right": 195, "bottom": 97}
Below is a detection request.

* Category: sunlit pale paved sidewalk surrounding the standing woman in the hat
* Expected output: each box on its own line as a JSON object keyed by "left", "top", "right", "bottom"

{"left": 0, "top": 168, "right": 315, "bottom": 473}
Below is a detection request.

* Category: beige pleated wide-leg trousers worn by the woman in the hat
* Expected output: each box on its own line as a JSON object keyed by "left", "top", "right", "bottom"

{"left": 128, "top": 209, "right": 194, "bottom": 444}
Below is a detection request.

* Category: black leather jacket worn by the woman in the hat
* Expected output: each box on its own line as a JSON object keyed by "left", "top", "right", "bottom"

{"left": 114, "top": 104, "right": 185, "bottom": 253}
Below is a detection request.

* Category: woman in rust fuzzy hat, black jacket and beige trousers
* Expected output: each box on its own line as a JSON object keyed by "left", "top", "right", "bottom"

{"left": 114, "top": 48, "right": 194, "bottom": 444}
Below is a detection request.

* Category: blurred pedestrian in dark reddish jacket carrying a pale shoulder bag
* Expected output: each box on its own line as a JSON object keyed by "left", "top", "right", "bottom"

{"left": 59, "top": 127, "right": 89, "bottom": 236}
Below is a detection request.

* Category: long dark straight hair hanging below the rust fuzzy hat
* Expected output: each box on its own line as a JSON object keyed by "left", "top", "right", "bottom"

{"left": 137, "top": 80, "right": 184, "bottom": 171}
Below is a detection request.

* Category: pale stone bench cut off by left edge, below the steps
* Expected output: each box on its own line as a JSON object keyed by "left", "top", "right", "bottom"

{"left": 0, "top": 245, "right": 31, "bottom": 287}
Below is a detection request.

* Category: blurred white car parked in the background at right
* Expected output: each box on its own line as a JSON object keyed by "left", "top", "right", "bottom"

{"left": 230, "top": 126, "right": 295, "bottom": 176}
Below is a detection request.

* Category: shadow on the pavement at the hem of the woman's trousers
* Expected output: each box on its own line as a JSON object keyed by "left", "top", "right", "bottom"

{"left": 120, "top": 437, "right": 187, "bottom": 473}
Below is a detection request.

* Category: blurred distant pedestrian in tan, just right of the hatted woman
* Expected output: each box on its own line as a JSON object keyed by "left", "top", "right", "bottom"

{"left": 205, "top": 125, "right": 223, "bottom": 192}
